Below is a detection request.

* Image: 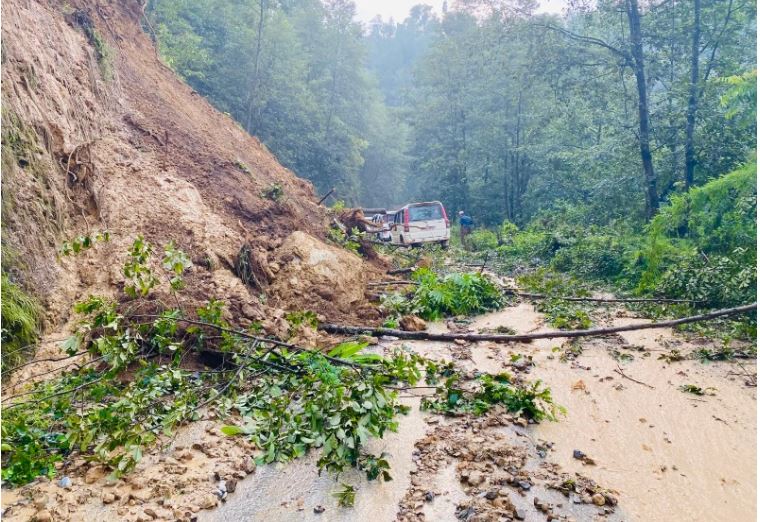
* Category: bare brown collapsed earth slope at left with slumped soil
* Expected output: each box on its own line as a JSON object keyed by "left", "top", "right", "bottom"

{"left": 2, "top": 0, "right": 380, "bottom": 331}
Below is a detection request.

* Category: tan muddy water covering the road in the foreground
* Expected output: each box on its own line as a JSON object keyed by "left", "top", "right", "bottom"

{"left": 199, "top": 303, "right": 757, "bottom": 522}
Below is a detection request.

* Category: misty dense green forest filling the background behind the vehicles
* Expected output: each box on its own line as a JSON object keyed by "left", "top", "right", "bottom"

{"left": 150, "top": 0, "right": 756, "bottom": 225}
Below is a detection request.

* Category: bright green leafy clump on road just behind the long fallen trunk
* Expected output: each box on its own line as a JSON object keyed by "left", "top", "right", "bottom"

{"left": 410, "top": 268, "right": 504, "bottom": 321}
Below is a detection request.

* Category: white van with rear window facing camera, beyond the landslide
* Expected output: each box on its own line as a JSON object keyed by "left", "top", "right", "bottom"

{"left": 391, "top": 201, "right": 451, "bottom": 247}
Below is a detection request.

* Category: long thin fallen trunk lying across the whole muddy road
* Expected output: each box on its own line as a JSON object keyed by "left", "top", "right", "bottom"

{"left": 319, "top": 303, "right": 757, "bottom": 343}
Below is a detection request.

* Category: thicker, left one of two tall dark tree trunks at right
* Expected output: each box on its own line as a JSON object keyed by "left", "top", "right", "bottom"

{"left": 626, "top": 0, "right": 659, "bottom": 219}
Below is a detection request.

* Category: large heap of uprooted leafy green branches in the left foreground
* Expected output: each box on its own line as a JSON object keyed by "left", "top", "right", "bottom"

{"left": 2, "top": 237, "right": 556, "bottom": 484}
